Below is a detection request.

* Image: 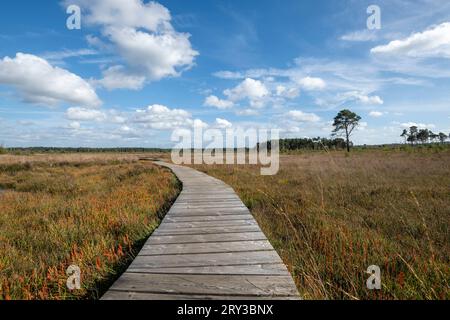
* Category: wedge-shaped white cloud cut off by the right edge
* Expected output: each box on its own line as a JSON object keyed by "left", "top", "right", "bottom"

{"left": 370, "top": 22, "right": 450, "bottom": 58}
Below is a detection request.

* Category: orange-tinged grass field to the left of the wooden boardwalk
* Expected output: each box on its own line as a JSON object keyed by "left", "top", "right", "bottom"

{"left": 0, "top": 154, "right": 180, "bottom": 299}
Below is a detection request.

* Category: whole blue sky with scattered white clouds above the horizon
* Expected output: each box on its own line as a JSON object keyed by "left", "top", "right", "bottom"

{"left": 0, "top": 0, "right": 450, "bottom": 147}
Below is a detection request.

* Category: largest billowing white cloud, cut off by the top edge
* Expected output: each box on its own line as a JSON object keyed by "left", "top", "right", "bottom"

{"left": 66, "top": 0, "right": 198, "bottom": 89}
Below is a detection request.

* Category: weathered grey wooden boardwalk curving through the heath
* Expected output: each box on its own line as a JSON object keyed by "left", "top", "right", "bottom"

{"left": 102, "top": 162, "right": 299, "bottom": 300}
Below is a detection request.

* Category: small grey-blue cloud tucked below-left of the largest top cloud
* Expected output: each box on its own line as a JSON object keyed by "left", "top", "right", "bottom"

{"left": 93, "top": 66, "right": 145, "bottom": 90}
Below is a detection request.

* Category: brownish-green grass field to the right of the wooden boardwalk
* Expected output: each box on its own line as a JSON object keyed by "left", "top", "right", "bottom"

{"left": 192, "top": 149, "right": 450, "bottom": 299}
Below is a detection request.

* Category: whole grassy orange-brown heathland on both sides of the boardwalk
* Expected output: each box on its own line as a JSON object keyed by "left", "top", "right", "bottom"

{"left": 0, "top": 146, "right": 450, "bottom": 299}
